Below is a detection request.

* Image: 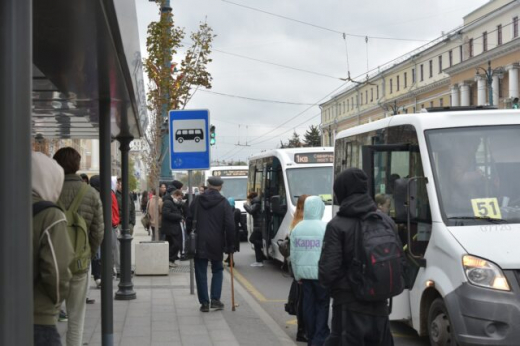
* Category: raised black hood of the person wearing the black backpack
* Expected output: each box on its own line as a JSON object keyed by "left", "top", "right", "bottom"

{"left": 334, "top": 168, "right": 377, "bottom": 217}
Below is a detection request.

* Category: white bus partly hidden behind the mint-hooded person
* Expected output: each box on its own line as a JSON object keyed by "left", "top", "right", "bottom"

{"left": 247, "top": 147, "right": 334, "bottom": 261}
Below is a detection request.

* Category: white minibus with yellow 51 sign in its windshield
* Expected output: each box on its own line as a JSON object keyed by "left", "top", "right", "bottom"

{"left": 334, "top": 109, "right": 520, "bottom": 346}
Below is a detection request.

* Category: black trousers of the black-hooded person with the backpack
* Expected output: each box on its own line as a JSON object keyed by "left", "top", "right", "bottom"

{"left": 325, "top": 305, "right": 394, "bottom": 346}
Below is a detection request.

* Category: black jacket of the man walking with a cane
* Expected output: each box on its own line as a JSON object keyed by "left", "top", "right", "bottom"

{"left": 186, "top": 189, "right": 235, "bottom": 261}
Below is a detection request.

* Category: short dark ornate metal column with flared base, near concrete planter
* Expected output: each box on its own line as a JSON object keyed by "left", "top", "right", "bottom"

{"left": 115, "top": 136, "right": 136, "bottom": 300}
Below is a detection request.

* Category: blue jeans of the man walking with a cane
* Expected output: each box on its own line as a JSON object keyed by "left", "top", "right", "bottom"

{"left": 194, "top": 258, "right": 224, "bottom": 304}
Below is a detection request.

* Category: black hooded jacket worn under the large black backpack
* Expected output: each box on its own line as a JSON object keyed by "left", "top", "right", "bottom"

{"left": 316, "top": 168, "right": 388, "bottom": 316}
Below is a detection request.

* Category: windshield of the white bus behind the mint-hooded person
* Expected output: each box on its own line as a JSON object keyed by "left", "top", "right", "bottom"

{"left": 287, "top": 166, "right": 332, "bottom": 205}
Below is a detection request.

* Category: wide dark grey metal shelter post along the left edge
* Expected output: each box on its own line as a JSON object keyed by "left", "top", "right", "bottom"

{"left": 0, "top": 0, "right": 33, "bottom": 346}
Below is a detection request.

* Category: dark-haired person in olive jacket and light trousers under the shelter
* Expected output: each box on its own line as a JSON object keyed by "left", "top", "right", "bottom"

{"left": 53, "top": 147, "right": 104, "bottom": 346}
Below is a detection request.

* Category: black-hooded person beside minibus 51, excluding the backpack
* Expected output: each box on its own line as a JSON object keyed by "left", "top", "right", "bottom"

{"left": 319, "top": 168, "right": 394, "bottom": 346}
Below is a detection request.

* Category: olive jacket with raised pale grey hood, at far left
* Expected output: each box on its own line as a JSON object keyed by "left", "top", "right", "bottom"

{"left": 32, "top": 152, "right": 74, "bottom": 325}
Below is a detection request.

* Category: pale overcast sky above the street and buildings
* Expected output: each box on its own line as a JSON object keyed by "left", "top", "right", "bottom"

{"left": 136, "top": 0, "right": 487, "bottom": 160}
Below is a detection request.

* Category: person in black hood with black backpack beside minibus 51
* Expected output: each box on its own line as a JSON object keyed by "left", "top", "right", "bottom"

{"left": 319, "top": 168, "right": 404, "bottom": 346}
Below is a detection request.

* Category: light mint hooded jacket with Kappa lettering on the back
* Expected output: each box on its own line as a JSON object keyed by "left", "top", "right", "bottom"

{"left": 290, "top": 196, "right": 327, "bottom": 281}
